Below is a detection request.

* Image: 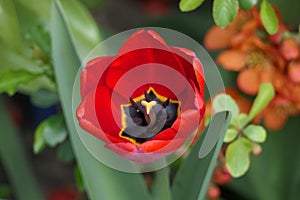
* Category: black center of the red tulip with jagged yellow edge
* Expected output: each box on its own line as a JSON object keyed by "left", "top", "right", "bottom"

{"left": 120, "top": 88, "right": 180, "bottom": 145}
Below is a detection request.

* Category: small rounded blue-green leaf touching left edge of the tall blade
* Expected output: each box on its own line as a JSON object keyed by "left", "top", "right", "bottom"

{"left": 37, "top": 114, "right": 68, "bottom": 147}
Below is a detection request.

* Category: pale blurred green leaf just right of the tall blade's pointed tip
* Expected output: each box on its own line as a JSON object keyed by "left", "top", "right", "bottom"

{"left": 60, "top": 0, "right": 101, "bottom": 60}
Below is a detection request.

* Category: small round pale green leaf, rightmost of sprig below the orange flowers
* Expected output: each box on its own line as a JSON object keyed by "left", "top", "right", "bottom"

{"left": 243, "top": 124, "right": 267, "bottom": 143}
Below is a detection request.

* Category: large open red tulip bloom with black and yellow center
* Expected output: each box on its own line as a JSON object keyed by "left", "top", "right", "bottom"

{"left": 76, "top": 30, "right": 205, "bottom": 162}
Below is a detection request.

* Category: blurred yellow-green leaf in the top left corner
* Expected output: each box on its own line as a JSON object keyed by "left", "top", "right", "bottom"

{"left": 0, "top": 0, "right": 22, "bottom": 49}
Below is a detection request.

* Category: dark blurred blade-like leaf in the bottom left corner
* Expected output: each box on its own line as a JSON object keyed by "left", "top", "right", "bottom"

{"left": 0, "top": 99, "right": 43, "bottom": 200}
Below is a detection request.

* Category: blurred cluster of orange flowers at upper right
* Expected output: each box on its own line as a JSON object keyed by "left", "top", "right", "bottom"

{"left": 204, "top": 8, "right": 300, "bottom": 130}
